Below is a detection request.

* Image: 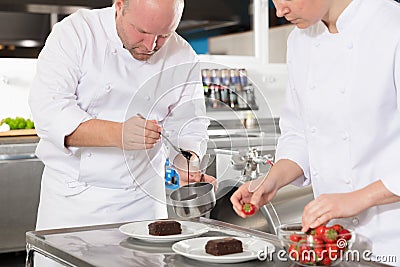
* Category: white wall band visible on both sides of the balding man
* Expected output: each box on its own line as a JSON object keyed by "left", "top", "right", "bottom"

{"left": 0, "top": 55, "right": 287, "bottom": 123}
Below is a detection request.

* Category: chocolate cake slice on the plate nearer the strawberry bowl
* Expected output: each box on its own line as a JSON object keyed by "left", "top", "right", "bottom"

{"left": 206, "top": 237, "right": 243, "bottom": 256}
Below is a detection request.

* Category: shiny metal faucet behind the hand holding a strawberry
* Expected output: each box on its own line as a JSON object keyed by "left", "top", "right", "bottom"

{"left": 231, "top": 148, "right": 273, "bottom": 181}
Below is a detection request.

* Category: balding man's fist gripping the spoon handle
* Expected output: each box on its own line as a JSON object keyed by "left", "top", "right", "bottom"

{"left": 122, "top": 116, "right": 162, "bottom": 150}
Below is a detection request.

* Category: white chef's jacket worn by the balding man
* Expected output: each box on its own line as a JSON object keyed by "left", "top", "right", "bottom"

{"left": 29, "top": 7, "right": 208, "bottom": 227}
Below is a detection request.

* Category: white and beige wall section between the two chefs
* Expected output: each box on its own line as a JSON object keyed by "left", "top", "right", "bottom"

{"left": 200, "top": 25, "right": 294, "bottom": 119}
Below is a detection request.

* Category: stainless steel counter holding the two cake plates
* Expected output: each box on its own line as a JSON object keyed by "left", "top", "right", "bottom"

{"left": 26, "top": 217, "right": 384, "bottom": 267}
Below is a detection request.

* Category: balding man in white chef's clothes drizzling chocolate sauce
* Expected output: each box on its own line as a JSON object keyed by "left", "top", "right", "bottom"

{"left": 29, "top": 0, "right": 213, "bottom": 241}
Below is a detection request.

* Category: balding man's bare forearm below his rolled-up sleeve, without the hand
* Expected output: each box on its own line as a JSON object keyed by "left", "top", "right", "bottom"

{"left": 65, "top": 119, "right": 122, "bottom": 147}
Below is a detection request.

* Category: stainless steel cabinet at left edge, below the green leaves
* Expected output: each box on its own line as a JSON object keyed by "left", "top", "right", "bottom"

{"left": 0, "top": 136, "right": 44, "bottom": 252}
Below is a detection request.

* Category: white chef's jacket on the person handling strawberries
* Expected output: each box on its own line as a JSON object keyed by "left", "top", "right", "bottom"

{"left": 276, "top": 0, "right": 400, "bottom": 264}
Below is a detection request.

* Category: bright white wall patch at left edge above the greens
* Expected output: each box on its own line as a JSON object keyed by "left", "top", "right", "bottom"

{"left": 0, "top": 58, "right": 36, "bottom": 120}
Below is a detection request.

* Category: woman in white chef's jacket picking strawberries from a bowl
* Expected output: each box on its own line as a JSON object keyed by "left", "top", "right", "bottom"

{"left": 231, "top": 0, "right": 400, "bottom": 264}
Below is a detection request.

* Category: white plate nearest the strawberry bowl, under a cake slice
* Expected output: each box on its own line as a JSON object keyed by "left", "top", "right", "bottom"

{"left": 172, "top": 236, "right": 275, "bottom": 263}
